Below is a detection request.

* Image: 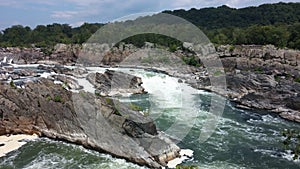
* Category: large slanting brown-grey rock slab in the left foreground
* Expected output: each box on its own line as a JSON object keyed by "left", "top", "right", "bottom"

{"left": 0, "top": 79, "right": 180, "bottom": 168}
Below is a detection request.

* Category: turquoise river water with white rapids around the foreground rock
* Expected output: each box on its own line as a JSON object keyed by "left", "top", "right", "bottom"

{"left": 0, "top": 71, "right": 300, "bottom": 169}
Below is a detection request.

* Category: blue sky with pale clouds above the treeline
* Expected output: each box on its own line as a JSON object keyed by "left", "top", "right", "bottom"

{"left": 0, "top": 0, "right": 300, "bottom": 30}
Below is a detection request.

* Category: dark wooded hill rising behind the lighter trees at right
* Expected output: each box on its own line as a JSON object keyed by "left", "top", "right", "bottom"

{"left": 164, "top": 2, "right": 300, "bottom": 29}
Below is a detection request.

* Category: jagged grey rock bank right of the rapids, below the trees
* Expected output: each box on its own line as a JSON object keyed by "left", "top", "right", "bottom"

{"left": 186, "top": 45, "right": 300, "bottom": 122}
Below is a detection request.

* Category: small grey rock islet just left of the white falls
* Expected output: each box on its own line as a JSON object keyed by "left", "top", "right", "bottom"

{"left": 87, "top": 70, "right": 146, "bottom": 96}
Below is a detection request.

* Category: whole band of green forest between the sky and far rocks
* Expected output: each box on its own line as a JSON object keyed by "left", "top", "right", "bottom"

{"left": 0, "top": 3, "right": 300, "bottom": 50}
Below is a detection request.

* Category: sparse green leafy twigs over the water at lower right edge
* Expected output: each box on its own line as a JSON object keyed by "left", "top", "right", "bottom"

{"left": 282, "top": 129, "right": 300, "bottom": 160}
